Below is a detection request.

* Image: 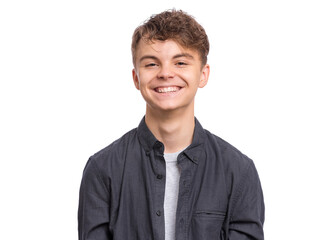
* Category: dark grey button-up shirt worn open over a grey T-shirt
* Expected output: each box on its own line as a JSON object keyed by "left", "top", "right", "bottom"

{"left": 78, "top": 119, "right": 264, "bottom": 240}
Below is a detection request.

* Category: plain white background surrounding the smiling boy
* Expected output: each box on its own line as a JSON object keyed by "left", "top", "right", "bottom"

{"left": 0, "top": 0, "right": 336, "bottom": 240}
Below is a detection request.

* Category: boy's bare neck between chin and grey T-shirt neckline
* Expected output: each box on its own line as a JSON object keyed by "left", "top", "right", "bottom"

{"left": 145, "top": 106, "right": 195, "bottom": 153}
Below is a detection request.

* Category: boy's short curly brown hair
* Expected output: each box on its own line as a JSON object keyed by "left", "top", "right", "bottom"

{"left": 132, "top": 9, "right": 210, "bottom": 66}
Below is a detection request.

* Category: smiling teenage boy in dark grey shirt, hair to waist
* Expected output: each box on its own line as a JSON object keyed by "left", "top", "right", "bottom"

{"left": 78, "top": 10, "right": 264, "bottom": 240}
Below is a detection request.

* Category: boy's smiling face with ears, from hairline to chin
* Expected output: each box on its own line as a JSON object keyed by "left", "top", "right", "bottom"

{"left": 133, "top": 40, "right": 209, "bottom": 111}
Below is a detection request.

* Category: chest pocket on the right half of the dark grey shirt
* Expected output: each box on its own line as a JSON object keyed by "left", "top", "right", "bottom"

{"left": 190, "top": 210, "right": 226, "bottom": 240}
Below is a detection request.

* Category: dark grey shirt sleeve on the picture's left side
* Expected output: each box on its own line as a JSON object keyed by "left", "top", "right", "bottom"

{"left": 78, "top": 159, "right": 112, "bottom": 240}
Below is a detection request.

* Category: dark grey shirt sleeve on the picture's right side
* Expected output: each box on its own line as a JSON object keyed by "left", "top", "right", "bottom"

{"left": 229, "top": 161, "right": 265, "bottom": 240}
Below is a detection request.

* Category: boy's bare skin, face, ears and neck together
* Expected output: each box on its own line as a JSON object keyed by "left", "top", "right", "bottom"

{"left": 132, "top": 40, "right": 210, "bottom": 153}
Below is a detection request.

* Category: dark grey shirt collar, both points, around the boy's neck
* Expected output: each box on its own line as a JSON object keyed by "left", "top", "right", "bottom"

{"left": 138, "top": 117, "right": 206, "bottom": 164}
